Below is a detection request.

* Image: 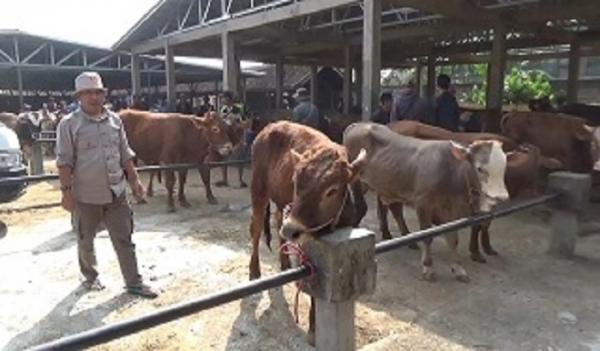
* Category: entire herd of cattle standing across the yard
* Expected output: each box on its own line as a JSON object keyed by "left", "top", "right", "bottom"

{"left": 0, "top": 102, "right": 600, "bottom": 346}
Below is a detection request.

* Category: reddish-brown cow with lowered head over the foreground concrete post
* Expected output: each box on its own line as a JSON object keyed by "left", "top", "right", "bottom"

{"left": 250, "top": 121, "right": 366, "bottom": 343}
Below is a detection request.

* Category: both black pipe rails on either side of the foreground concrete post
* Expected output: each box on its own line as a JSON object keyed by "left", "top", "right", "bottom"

{"left": 28, "top": 194, "right": 559, "bottom": 350}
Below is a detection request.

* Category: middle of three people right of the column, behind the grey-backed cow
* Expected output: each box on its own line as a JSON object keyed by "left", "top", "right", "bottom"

{"left": 390, "top": 80, "right": 434, "bottom": 124}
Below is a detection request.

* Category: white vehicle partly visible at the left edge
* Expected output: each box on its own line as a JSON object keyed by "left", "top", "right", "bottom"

{"left": 0, "top": 123, "right": 27, "bottom": 203}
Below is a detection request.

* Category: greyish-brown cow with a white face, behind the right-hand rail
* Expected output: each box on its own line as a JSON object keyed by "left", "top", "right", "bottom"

{"left": 344, "top": 123, "right": 508, "bottom": 281}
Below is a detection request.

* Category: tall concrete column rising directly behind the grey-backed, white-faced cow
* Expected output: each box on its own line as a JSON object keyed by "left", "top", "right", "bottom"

{"left": 362, "top": 0, "right": 381, "bottom": 121}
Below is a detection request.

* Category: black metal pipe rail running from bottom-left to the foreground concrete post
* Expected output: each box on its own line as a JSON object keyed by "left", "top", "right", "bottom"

{"left": 31, "top": 266, "right": 311, "bottom": 351}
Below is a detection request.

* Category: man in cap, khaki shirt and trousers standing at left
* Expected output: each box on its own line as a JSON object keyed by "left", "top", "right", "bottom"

{"left": 56, "top": 72, "right": 158, "bottom": 298}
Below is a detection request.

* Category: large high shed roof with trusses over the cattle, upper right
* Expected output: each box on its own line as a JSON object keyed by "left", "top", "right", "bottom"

{"left": 113, "top": 0, "right": 600, "bottom": 66}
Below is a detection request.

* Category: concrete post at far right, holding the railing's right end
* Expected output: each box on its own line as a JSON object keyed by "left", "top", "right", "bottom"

{"left": 548, "top": 172, "right": 591, "bottom": 258}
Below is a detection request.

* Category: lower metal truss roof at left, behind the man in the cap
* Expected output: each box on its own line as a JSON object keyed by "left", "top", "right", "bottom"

{"left": 0, "top": 30, "right": 261, "bottom": 91}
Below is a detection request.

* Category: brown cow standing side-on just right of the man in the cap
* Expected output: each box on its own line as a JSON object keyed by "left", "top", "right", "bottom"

{"left": 119, "top": 110, "right": 232, "bottom": 212}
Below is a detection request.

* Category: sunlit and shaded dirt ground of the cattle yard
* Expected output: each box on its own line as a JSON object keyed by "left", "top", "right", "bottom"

{"left": 0, "top": 171, "right": 600, "bottom": 351}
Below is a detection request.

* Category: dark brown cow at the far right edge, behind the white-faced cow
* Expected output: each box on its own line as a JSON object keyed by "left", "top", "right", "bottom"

{"left": 502, "top": 112, "right": 600, "bottom": 173}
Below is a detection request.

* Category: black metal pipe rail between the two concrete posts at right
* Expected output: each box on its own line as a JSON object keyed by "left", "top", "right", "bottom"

{"left": 375, "top": 194, "right": 559, "bottom": 254}
